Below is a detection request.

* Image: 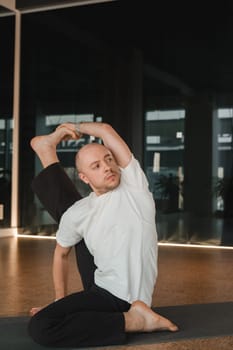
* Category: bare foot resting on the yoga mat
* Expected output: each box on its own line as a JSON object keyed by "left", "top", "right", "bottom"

{"left": 124, "top": 301, "right": 178, "bottom": 332}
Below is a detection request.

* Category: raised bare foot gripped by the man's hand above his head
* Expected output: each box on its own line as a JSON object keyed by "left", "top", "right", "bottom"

{"left": 30, "top": 127, "right": 78, "bottom": 168}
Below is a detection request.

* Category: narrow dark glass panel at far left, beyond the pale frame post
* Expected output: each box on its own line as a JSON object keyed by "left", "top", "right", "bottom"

{"left": 0, "top": 13, "right": 14, "bottom": 227}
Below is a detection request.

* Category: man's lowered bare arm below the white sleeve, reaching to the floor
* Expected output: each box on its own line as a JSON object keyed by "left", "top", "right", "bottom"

{"left": 53, "top": 243, "right": 71, "bottom": 300}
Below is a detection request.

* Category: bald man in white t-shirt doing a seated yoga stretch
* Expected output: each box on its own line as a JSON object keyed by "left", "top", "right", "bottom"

{"left": 29, "top": 123, "right": 177, "bottom": 347}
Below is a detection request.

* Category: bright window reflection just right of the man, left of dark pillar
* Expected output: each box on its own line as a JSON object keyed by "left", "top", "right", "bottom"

{"left": 145, "top": 110, "right": 185, "bottom": 241}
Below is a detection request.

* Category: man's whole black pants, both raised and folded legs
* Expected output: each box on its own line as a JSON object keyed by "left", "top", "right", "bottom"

{"left": 28, "top": 163, "right": 130, "bottom": 347}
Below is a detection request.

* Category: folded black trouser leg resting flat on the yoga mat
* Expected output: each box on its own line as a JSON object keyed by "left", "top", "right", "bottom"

{"left": 29, "top": 286, "right": 130, "bottom": 347}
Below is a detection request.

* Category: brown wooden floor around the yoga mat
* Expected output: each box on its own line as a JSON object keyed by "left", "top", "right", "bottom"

{"left": 0, "top": 237, "right": 233, "bottom": 350}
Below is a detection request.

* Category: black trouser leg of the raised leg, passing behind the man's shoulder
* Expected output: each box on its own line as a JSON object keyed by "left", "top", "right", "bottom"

{"left": 32, "top": 163, "right": 96, "bottom": 289}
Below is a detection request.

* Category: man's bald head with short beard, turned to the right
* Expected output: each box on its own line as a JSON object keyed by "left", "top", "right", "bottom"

{"left": 76, "top": 144, "right": 120, "bottom": 195}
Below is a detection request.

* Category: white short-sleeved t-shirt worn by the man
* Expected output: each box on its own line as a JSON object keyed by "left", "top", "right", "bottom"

{"left": 57, "top": 156, "right": 157, "bottom": 306}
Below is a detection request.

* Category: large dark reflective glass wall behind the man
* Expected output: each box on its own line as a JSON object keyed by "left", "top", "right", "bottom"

{"left": 20, "top": 1, "right": 233, "bottom": 246}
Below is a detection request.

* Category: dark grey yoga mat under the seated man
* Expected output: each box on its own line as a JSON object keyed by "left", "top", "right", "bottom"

{"left": 0, "top": 302, "right": 233, "bottom": 350}
